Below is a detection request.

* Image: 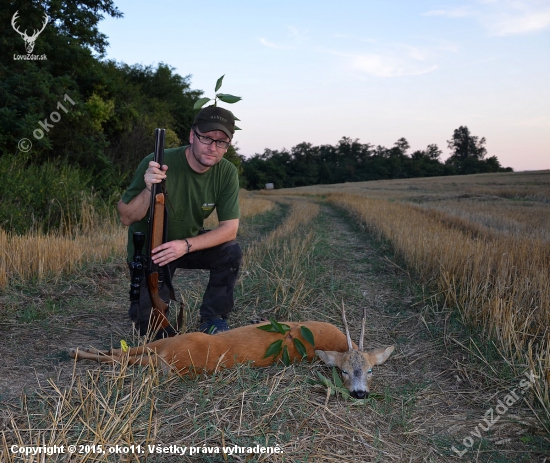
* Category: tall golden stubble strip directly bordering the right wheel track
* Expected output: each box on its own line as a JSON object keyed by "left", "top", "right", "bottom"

{"left": 329, "top": 194, "right": 550, "bottom": 418}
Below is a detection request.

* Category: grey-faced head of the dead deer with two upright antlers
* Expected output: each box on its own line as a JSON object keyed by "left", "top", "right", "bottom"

{"left": 315, "top": 303, "right": 395, "bottom": 399}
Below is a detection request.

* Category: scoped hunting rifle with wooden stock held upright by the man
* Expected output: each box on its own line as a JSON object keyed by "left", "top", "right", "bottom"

{"left": 130, "top": 129, "right": 181, "bottom": 338}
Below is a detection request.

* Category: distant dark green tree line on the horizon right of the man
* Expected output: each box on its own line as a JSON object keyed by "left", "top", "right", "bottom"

{"left": 242, "top": 126, "right": 512, "bottom": 189}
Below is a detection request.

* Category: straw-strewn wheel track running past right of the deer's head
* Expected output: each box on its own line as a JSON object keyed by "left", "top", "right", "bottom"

{"left": 316, "top": 206, "right": 549, "bottom": 462}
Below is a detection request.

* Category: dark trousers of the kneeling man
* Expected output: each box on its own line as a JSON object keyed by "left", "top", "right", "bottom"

{"left": 129, "top": 241, "right": 243, "bottom": 333}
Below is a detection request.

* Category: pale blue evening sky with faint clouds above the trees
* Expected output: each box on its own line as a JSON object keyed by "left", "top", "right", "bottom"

{"left": 99, "top": 0, "right": 550, "bottom": 171}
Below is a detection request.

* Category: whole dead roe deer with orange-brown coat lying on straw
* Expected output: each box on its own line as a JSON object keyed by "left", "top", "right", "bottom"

{"left": 69, "top": 313, "right": 394, "bottom": 398}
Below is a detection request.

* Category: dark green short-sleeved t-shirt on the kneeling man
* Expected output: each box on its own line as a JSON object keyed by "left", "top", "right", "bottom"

{"left": 122, "top": 146, "right": 240, "bottom": 262}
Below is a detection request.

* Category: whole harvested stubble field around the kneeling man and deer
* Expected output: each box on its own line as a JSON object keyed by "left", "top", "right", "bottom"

{"left": 0, "top": 172, "right": 550, "bottom": 463}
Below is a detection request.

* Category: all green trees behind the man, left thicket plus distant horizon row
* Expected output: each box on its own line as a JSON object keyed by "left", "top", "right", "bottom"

{"left": 0, "top": 0, "right": 512, "bottom": 233}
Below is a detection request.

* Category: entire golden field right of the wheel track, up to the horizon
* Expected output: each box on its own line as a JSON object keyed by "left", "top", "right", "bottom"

{"left": 270, "top": 172, "right": 550, "bottom": 419}
